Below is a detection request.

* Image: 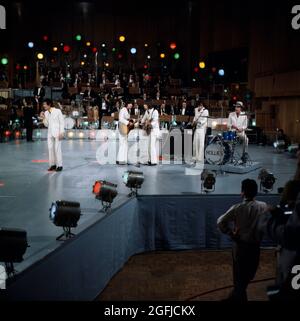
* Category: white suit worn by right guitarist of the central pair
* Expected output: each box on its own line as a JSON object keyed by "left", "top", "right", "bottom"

{"left": 142, "top": 108, "right": 159, "bottom": 164}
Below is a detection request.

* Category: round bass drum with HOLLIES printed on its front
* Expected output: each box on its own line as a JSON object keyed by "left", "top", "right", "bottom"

{"left": 205, "top": 141, "right": 231, "bottom": 165}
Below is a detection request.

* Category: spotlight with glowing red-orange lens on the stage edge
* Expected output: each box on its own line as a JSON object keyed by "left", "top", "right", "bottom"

{"left": 93, "top": 181, "right": 118, "bottom": 212}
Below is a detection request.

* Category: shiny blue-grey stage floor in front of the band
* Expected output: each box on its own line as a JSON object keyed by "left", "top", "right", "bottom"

{"left": 0, "top": 140, "right": 296, "bottom": 270}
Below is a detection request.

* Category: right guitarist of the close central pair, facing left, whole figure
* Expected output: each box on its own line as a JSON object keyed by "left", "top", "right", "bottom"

{"left": 141, "top": 103, "right": 159, "bottom": 166}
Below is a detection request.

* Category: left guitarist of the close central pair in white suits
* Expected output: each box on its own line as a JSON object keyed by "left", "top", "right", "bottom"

{"left": 117, "top": 103, "right": 134, "bottom": 165}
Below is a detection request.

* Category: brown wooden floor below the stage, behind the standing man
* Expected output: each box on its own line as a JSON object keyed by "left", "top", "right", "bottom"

{"left": 98, "top": 250, "right": 276, "bottom": 301}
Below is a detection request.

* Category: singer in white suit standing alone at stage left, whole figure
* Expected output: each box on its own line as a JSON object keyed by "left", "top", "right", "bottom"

{"left": 42, "top": 99, "right": 65, "bottom": 172}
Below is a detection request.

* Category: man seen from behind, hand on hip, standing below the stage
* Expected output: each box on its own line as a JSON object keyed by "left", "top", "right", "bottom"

{"left": 217, "top": 179, "right": 268, "bottom": 301}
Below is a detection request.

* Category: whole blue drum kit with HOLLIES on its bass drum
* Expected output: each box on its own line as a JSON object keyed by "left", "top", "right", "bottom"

{"left": 204, "top": 130, "right": 249, "bottom": 166}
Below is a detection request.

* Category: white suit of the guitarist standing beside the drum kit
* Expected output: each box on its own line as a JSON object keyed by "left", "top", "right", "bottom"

{"left": 193, "top": 107, "right": 209, "bottom": 163}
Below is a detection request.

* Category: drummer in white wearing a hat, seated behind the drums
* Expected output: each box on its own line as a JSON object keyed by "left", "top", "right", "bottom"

{"left": 227, "top": 101, "right": 249, "bottom": 155}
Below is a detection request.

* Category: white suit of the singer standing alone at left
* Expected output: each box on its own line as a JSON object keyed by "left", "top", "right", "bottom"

{"left": 43, "top": 108, "right": 65, "bottom": 167}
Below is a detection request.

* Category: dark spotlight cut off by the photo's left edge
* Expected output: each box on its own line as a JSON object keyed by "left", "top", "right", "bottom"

{"left": 0, "top": 228, "right": 28, "bottom": 277}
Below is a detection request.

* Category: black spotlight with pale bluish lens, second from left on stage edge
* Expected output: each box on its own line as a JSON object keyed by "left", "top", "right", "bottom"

{"left": 49, "top": 201, "right": 81, "bottom": 241}
